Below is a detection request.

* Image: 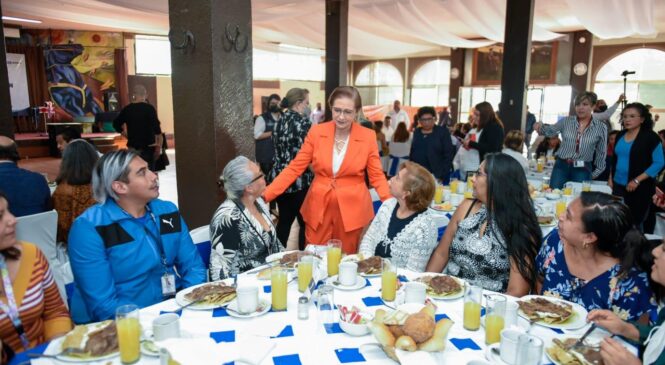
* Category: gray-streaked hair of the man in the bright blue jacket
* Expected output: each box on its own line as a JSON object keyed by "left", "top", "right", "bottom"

{"left": 92, "top": 149, "right": 140, "bottom": 204}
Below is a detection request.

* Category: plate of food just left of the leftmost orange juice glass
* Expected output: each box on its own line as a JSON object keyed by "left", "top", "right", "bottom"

{"left": 45, "top": 320, "right": 119, "bottom": 363}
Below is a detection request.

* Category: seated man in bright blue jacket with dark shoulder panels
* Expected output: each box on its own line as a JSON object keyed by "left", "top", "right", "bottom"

{"left": 68, "top": 150, "right": 206, "bottom": 323}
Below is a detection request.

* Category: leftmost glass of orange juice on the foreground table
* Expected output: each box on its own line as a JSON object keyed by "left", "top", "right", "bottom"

{"left": 115, "top": 304, "right": 141, "bottom": 364}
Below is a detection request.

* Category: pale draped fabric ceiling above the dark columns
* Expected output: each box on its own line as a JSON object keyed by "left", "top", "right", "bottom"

{"left": 2, "top": 0, "right": 665, "bottom": 58}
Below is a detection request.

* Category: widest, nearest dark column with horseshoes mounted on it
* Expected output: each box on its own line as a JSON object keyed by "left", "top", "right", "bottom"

{"left": 169, "top": 0, "right": 254, "bottom": 228}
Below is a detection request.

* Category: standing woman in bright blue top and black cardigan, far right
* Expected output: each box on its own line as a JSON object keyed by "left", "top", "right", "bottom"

{"left": 609, "top": 103, "right": 665, "bottom": 229}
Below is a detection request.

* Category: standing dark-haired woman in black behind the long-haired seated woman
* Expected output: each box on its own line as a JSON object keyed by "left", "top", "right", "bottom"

{"left": 464, "top": 101, "right": 504, "bottom": 162}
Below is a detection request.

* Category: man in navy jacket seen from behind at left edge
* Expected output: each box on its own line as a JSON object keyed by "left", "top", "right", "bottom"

{"left": 0, "top": 136, "right": 51, "bottom": 217}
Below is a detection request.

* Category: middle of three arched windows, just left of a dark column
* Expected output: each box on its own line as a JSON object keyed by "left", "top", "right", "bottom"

{"left": 411, "top": 60, "right": 450, "bottom": 106}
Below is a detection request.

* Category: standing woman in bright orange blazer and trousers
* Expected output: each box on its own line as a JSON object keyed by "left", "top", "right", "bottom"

{"left": 264, "top": 86, "right": 390, "bottom": 253}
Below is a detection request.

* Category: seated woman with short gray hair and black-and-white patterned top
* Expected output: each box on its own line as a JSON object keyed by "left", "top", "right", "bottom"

{"left": 210, "top": 156, "right": 283, "bottom": 280}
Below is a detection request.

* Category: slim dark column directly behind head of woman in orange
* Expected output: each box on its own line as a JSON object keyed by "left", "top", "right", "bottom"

{"left": 325, "top": 0, "right": 349, "bottom": 120}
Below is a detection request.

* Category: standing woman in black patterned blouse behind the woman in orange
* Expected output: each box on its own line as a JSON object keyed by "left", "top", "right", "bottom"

{"left": 269, "top": 88, "right": 314, "bottom": 250}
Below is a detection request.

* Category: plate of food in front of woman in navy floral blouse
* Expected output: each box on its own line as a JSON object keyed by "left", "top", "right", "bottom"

{"left": 517, "top": 295, "right": 589, "bottom": 330}
